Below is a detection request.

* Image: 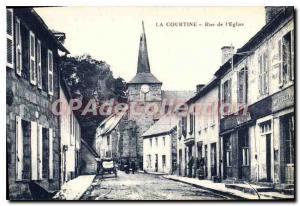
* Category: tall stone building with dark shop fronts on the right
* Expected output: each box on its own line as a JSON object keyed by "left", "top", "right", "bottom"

{"left": 216, "top": 7, "right": 295, "bottom": 191}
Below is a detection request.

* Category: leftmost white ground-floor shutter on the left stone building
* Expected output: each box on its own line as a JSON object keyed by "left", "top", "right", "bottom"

{"left": 16, "top": 116, "right": 23, "bottom": 181}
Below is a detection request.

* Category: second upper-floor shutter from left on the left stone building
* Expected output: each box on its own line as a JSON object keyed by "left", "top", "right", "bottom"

{"left": 15, "top": 18, "right": 22, "bottom": 76}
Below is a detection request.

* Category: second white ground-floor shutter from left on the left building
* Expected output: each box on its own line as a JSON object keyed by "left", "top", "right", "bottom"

{"left": 30, "top": 122, "right": 38, "bottom": 180}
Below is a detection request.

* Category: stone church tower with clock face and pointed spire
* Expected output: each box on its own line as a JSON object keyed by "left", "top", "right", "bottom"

{"left": 127, "top": 22, "right": 162, "bottom": 169}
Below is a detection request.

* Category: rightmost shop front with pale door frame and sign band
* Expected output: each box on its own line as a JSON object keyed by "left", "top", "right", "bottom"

{"left": 250, "top": 86, "right": 295, "bottom": 184}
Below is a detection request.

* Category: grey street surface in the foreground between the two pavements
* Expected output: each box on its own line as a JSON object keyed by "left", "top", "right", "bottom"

{"left": 81, "top": 171, "right": 232, "bottom": 200}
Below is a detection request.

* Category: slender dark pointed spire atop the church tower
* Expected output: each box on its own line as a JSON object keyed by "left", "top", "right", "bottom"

{"left": 137, "top": 21, "right": 150, "bottom": 73}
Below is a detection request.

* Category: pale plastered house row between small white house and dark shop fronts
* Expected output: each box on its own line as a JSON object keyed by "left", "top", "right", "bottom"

{"left": 177, "top": 78, "right": 220, "bottom": 179}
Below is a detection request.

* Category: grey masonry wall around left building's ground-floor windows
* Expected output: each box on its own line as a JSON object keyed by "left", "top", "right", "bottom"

{"left": 6, "top": 32, "right": 60, "bottom": 199}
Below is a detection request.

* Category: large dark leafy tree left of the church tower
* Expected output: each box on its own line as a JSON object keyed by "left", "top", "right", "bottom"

{"left": 61, "top": 54, "right": 127, "bottom": 145}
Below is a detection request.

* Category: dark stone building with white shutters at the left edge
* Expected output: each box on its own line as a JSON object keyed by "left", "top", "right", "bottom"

{"left": 6, "top": 7, "right": 68, "bottom": 200}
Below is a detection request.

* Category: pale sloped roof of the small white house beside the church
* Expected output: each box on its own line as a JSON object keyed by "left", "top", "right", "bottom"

{"left": 142, "top": 114, "right": 178, "bottom": 138}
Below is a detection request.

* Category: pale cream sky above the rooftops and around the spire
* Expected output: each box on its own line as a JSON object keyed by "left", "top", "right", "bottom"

{"left": 35, "top": 7, "right": 265, "bottom": 90}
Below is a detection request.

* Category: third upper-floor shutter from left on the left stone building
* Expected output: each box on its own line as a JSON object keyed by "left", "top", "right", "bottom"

{"left": 29, "top": 31, "right": 36, "bottom": 85}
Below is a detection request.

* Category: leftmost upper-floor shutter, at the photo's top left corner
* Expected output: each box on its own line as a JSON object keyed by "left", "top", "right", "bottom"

{"left": 6, "top": 9, "right": 14, "bottom": 69}
